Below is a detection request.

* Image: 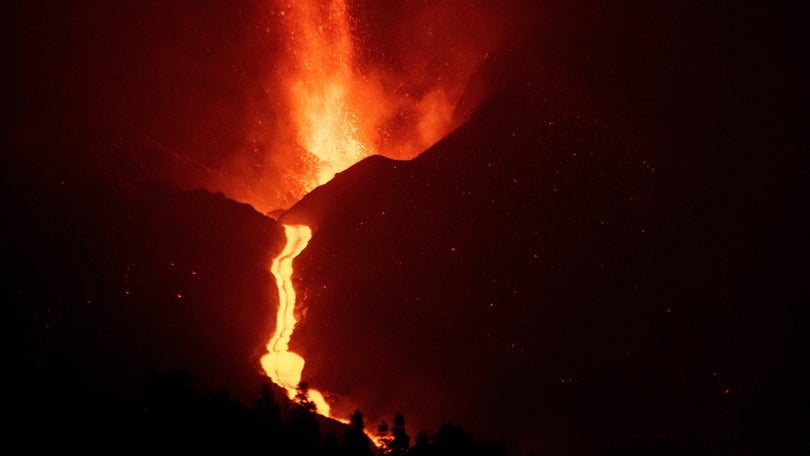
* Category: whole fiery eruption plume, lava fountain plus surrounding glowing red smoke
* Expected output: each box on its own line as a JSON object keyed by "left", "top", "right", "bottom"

{"left": 210, "top": 0, "right": 503, "bottom": 213}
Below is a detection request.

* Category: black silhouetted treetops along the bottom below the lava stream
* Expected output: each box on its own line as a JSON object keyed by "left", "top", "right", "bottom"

{"left": 6, "top": 371, "right": 508, "bottom": 456}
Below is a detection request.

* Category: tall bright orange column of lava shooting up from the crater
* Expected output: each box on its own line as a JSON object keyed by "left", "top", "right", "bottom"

{"left": 279, "top": 0, "right": 375, "bottom": 192}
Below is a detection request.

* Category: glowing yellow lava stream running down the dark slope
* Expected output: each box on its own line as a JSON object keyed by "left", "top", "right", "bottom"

{"left": 261, "top": 225, "right": 329, "bottom": 416}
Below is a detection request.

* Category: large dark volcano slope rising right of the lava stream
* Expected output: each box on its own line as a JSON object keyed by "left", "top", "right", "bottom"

{"left": 280, "top": 51, "right": 793, "bottom": 454}
